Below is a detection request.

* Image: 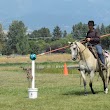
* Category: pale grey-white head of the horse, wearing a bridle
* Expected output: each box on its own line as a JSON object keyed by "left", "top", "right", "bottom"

{"left": 68, "top": 42, "right": 79, "bottom": 60}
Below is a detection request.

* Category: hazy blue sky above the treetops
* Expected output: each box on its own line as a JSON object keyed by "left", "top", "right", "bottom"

{"left": 0, "top": 0, "right": 110, "bottom": 31}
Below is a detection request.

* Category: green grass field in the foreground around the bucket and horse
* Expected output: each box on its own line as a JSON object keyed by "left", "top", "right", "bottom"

{"left": 0, "top": 54, "right": 110, "bottom": 110}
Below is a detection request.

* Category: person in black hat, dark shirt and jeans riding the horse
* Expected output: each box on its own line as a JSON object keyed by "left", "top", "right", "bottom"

{"left": 86, "top": 21, "right": 106, "bottom": 69}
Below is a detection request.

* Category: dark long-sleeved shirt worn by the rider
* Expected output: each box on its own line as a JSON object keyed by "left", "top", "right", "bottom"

{"left": 86, "top": 29, "right": 100, "bottom": 45}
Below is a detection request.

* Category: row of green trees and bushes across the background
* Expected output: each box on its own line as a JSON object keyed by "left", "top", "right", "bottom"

{"left": 0, "top": 20, "right": 110, "bottom": 55}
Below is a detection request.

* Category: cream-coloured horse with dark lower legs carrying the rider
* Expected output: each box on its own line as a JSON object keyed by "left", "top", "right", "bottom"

{"left": 69, "top": 42, "right": 110, "bottom": 95}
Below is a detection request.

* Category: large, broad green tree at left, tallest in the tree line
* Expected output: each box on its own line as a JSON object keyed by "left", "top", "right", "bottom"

{"left": 7, "top": 21, "right": 29, "bottom": 54}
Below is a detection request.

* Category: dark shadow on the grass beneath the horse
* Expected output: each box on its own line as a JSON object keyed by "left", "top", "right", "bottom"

{"left": 62, "top": 91, "right": 103, "bottom": 96}
